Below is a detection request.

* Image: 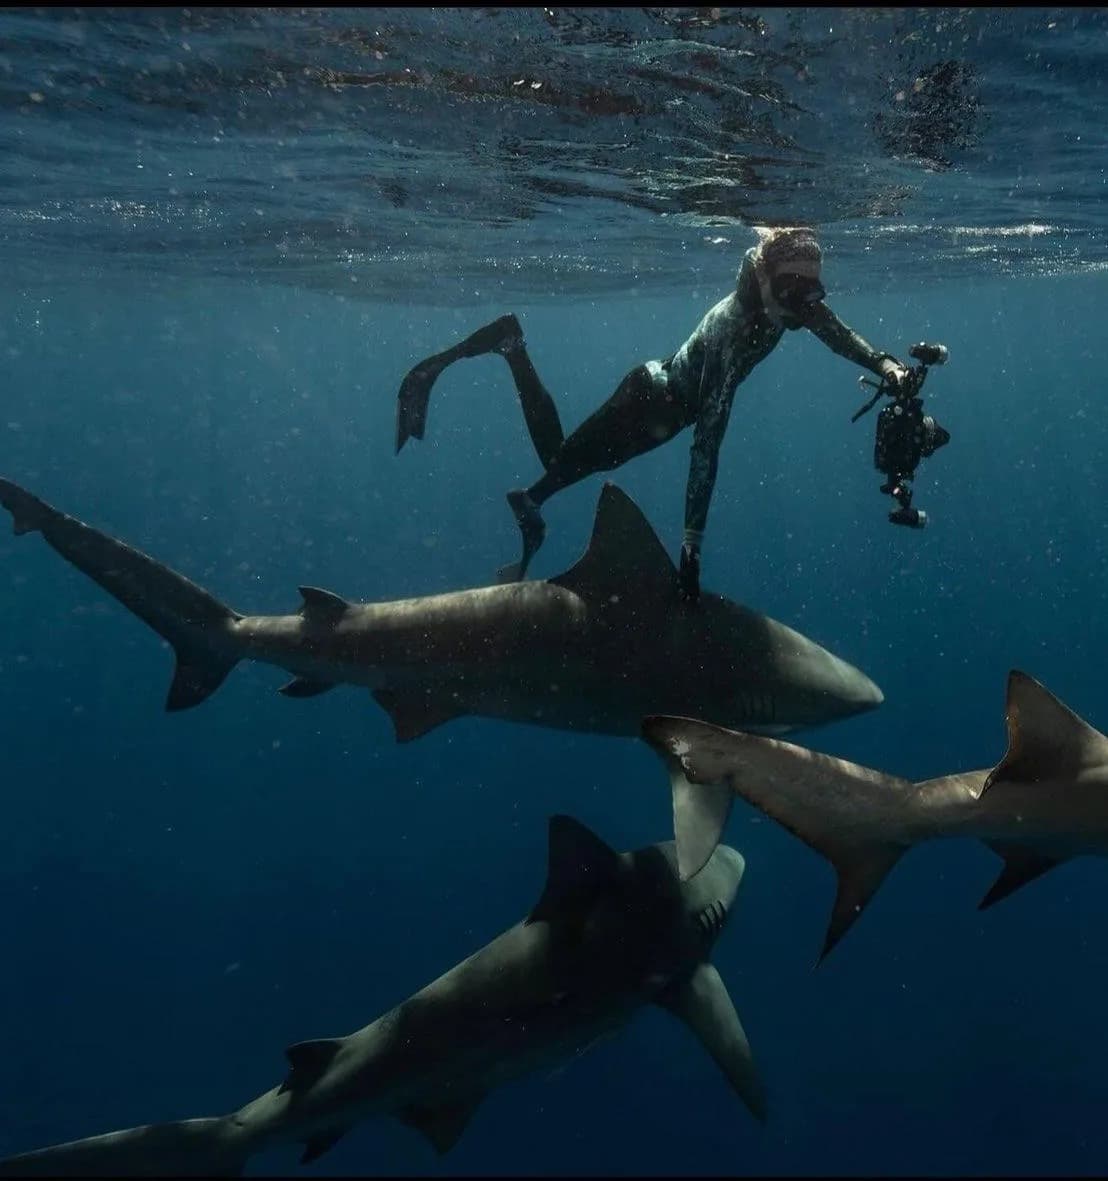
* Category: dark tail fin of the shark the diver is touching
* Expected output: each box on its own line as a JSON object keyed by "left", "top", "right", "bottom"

{"left": 0, "top": 479, "right": 242, "bottom": 711}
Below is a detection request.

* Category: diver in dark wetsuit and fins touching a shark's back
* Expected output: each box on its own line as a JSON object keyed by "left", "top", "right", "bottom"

{"left": 397, "top": 229, "right": 907, "bottom": 602}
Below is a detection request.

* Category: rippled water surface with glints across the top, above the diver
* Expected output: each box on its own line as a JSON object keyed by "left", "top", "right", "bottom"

{"left": 0, "top": 7, "right": 1108, "bottom": 304}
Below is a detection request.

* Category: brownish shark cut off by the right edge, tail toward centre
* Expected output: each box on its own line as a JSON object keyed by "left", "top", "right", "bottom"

{"left": 643, "top": 670, "right": 1108, "bottom": 959}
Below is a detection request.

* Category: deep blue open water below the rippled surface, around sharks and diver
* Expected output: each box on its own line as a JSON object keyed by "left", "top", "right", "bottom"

{"left": 0, "top": 9, "right": 1108, "bottom": 1175}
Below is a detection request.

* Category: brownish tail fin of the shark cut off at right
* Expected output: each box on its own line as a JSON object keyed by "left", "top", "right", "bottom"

{"left": 643, "top": 716, "right": 915, "bottom": 960}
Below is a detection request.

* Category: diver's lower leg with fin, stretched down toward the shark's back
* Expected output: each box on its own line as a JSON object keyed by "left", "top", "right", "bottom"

{"left": 498, "top": 365, "right": 690, "bottom": 582}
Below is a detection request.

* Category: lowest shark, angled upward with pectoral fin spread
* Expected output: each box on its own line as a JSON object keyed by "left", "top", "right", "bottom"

{"left": 0, "top": 816, "right": 765, "bottom": 1176}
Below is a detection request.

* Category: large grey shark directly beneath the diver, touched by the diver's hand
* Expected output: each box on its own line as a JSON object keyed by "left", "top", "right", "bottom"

{"left": 0, "top": 479, "right": 884, "bottom": 742}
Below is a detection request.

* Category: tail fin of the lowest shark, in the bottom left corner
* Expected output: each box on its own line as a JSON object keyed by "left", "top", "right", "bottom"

{"left": 0, "top": 1116, "right": 249, "bottom": 1177}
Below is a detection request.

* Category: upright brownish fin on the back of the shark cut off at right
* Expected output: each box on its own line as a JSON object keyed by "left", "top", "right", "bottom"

{"left": 982, "top": 668, "right": 1108, "bottom": 794}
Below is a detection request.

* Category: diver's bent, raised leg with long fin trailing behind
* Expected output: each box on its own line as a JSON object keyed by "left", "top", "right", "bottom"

{"left": 396, "top": 314, "right": 562, "bottom": 466}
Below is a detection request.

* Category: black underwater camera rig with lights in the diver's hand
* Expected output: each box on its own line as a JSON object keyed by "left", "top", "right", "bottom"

{"left": 850, "top": 342, "right": 950, "bottom": 529}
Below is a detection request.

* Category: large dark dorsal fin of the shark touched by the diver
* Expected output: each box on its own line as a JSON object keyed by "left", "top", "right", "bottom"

{"left": 550, "top": 483, "right": 677, "bottom": 601}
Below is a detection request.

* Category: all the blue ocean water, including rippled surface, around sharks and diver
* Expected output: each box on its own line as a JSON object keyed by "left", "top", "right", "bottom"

{"left": 0, "top": 8, "right": 1108, "bottom": 1176}
